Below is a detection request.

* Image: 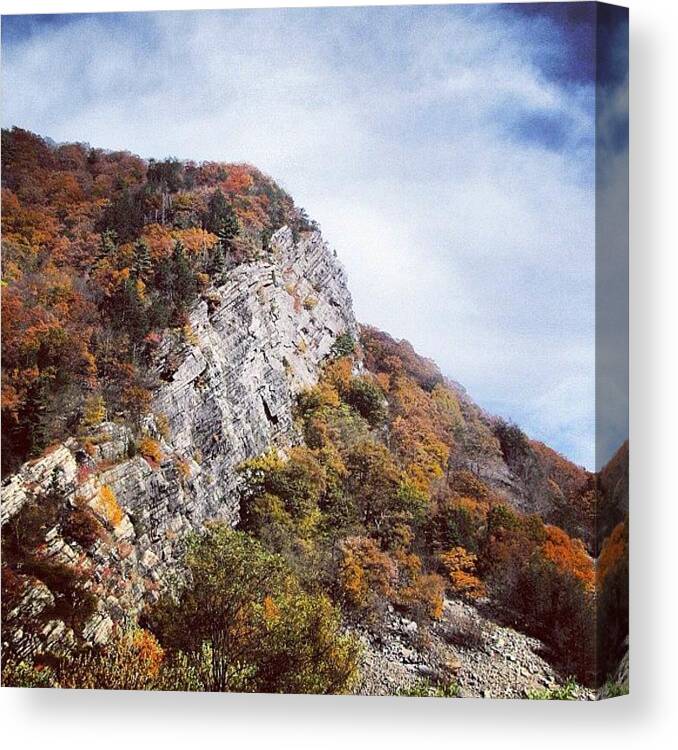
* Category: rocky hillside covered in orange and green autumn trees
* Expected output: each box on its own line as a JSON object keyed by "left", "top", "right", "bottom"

{"left": 2, "top": 129, "right": 628, "bottom": 697}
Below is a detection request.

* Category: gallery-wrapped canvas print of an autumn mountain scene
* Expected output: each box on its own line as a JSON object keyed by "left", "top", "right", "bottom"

{"left": 1, "top": 2, "right": 629, "bottom": 700}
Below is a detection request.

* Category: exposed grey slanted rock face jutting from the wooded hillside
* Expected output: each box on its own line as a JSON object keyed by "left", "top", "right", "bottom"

{"left": 2, "top": 227, "right": 357, "bottom": 654}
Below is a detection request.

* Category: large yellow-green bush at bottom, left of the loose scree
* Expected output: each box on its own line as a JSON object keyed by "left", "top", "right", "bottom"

{"left": 146, "top": 524, "right": 358, "bottom": 693}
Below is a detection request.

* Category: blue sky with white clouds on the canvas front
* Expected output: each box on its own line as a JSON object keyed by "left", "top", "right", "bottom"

{"left": 2, "top": 3, "right": 628, "bottom": 468}
